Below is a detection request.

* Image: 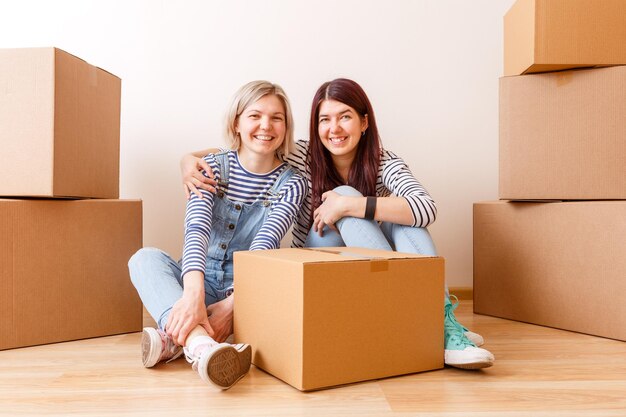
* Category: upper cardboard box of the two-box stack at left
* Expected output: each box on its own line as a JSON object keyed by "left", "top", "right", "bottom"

{"left": 0, "top": 48, "right": 121, "bottom": 198}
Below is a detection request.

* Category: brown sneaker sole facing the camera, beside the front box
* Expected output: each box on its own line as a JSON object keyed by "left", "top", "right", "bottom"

{"left": 199, "top": 344, "right": 252, "bottom": 389}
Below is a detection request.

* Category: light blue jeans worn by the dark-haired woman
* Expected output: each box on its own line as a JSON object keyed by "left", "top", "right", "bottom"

{"left": 305, "top": 185, "right": 448, "bottom": 298}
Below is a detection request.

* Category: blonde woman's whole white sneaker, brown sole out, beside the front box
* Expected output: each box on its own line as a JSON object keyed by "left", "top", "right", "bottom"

{"left": 184, "top": 338, "right": 252, "bottom": 390}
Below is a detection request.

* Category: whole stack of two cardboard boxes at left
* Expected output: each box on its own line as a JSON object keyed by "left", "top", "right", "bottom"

{"left": 0, "top": 48, "right": 142, "bottom": 349}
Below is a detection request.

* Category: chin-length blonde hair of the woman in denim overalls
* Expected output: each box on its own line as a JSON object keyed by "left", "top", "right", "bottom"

{"left": 225, "top": 81, "right": 294, "bottom": 156}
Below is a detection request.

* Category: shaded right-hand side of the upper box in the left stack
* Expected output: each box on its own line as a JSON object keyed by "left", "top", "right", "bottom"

{"left": 53, "top": 49, "right": 121, "bottom": 198}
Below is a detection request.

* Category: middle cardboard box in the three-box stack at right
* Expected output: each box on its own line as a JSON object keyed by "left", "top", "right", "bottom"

{"left": 499, "top": 66, "right": 626, "bottom": 200}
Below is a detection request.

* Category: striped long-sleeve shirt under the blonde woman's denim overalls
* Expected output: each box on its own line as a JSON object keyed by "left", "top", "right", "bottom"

{"left": 182, "top": 151, "right": 308, "bottom": 276}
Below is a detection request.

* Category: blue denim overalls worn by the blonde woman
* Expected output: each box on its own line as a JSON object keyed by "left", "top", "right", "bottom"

{"left": 128, "top": 152, "right": 295, "bottom": 329}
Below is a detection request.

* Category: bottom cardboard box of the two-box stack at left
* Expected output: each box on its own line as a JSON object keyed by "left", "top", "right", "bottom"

{"left": 0, "top": 199, "right": 142, "bottom": 349}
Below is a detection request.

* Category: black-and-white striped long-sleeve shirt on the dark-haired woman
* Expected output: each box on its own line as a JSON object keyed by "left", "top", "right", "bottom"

{"left": 287, "top": 140, "right": 437, "bottom": 247}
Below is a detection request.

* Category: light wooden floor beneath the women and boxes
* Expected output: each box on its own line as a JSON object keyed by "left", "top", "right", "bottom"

{"left": 0, "top": 301, "right": 626, "bottom": 417}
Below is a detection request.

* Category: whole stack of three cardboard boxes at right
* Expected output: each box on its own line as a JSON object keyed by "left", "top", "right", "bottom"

{"left": 474, "top": 0, "right": 626, "bottom": 341}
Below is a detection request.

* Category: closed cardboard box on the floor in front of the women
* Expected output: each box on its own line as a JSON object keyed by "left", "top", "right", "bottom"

{"left": 234, "top": 248, "right": 444, "bottom": 391}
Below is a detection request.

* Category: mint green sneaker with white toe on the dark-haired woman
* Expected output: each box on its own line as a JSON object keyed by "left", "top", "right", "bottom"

{"left": 443, "top": 299, "right": 495, "bottom": 369}
